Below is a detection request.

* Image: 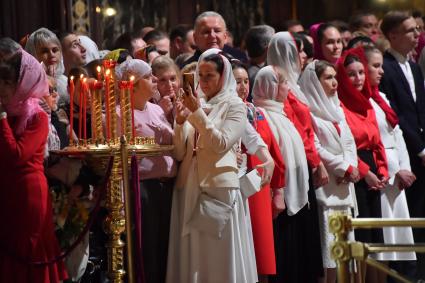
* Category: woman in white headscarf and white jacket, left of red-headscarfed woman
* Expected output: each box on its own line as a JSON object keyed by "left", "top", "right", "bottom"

{"left": 299, "top": 60, "right": 360, "bottom": 283}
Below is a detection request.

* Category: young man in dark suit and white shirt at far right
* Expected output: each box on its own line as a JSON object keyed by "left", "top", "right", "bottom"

{"left": 380, "top": 11, "right": 425, "bottom": 278}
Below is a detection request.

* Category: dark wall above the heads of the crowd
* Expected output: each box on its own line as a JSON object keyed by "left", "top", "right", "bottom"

{"left": 0, "top": 0, "right": 425, "bottom": 48}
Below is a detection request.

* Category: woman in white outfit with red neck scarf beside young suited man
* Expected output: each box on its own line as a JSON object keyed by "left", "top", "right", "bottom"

{"left": 363, "top": 47, "right": 416, "bottom": 280}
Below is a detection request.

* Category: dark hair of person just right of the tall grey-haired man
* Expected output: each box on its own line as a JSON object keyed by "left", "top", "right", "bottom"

{"left": 245, "top": 25, "right": 274, "bottom": 58}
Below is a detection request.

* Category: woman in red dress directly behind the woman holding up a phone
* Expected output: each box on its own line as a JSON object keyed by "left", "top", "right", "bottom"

{"left": 232, "top": 62, "right": 285, "bottom": 282}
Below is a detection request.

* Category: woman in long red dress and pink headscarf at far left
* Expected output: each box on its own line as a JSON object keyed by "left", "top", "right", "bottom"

{"left": 0, "top": 41, "right": 66, "bottom": 283}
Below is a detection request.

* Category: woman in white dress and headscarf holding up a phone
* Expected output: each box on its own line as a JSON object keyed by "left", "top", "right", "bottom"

{"left": 167, "top": 49, "right": 258, "bottom": 283}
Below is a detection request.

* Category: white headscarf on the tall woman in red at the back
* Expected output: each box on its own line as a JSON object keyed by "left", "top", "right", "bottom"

{"left": 267, "top": 31, "right": 307, "bottom": 103}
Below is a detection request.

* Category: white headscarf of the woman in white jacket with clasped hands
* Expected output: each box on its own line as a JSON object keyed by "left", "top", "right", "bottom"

{"left": 299, "top": 60, "right": 344, "bottom": 123}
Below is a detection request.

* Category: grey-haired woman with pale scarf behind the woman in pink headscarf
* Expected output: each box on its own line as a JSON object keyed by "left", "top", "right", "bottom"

{"left": 25, "top": 28, "right": 69, "bottom": 104}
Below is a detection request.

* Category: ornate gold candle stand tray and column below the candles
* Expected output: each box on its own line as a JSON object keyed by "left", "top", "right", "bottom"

{"left": 52, "top": 136, "right": 173, "bottom": 283}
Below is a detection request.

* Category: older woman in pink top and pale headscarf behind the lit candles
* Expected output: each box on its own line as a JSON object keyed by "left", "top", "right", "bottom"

{"left": 116, "top": 59, "right": 177, "bottom": 282}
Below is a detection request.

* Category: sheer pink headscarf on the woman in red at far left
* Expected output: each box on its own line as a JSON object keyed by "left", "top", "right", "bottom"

{"left": 5, "top": 49, "right": 49, "bottom": 135}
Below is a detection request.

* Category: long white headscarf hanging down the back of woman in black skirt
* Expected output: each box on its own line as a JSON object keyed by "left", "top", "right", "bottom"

{"left": 252, "top": 66, "right": 309, "bottom": 215}
